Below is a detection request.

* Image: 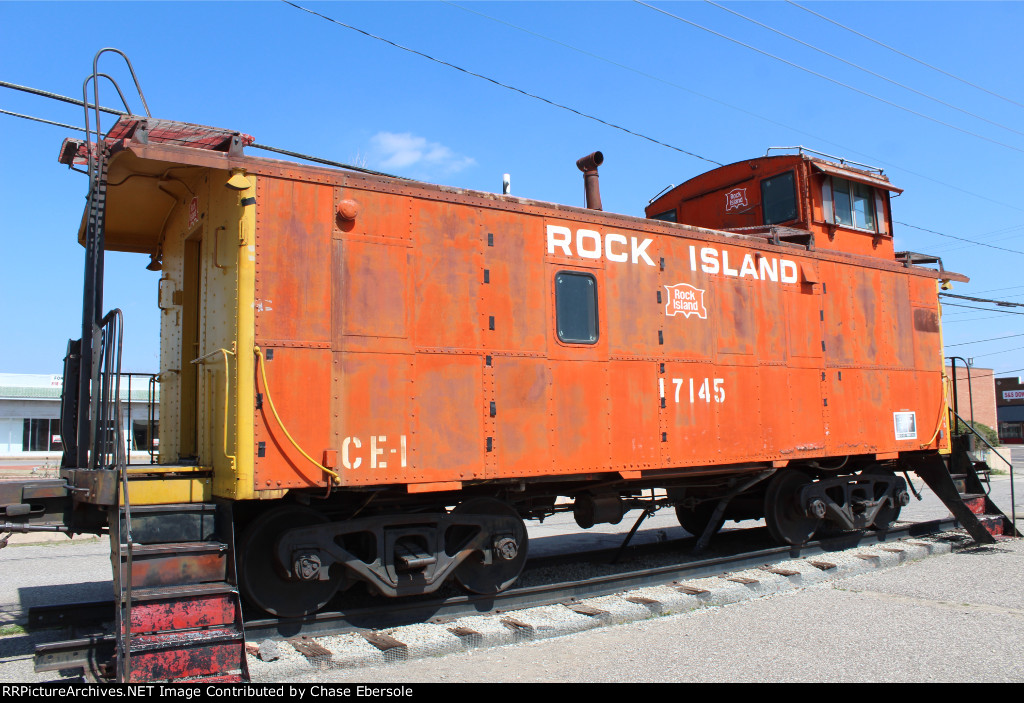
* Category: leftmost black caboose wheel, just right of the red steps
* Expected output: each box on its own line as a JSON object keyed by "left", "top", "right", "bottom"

{"left": 239, "top": 506, "right": 343, "bottom": 617}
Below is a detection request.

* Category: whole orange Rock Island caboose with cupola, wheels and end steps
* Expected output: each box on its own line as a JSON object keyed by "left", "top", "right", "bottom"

{"left": 0, "top": 56, "right": 1016, "bottom": 680}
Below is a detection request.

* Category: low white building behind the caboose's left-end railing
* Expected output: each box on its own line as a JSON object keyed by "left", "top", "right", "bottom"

{"left": 0, "top": 374, "right": 160, "bottom": 462}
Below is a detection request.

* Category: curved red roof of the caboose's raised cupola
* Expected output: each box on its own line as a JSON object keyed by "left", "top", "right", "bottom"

{"left": 646, "top": 150, "right": 903, "bottom": 215}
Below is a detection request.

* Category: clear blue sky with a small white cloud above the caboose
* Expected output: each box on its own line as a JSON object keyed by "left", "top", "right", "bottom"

{"left": 0, "top": 0, "right": 1024, "bottom": 384}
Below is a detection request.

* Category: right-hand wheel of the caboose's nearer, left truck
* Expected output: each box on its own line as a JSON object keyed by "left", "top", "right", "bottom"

{"left": 453, "top": 498, "right": 528, "bottom": 596}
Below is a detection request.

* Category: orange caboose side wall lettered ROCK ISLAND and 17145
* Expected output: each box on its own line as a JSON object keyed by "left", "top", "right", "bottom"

{"left": 241, "top": 162, "right": 941, "bottom": 489}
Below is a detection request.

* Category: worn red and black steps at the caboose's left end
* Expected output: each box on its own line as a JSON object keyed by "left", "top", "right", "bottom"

{"left": 112, "top": 503, "right": 249, "bottom": 683}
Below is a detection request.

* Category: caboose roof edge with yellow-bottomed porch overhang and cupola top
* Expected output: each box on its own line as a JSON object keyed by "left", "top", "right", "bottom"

{"left": 59, "top": 116, "right": 967, "bottom": 280}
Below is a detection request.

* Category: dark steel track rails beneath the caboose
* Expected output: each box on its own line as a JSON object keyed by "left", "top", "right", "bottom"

{"left": 34, "top": 517, "right": 957, "bottom": 676}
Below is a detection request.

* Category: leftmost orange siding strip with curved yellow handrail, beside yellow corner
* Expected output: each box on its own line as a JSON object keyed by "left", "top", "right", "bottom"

{"left": 253, "top": 178, "right": 334, "bottom": 490}
